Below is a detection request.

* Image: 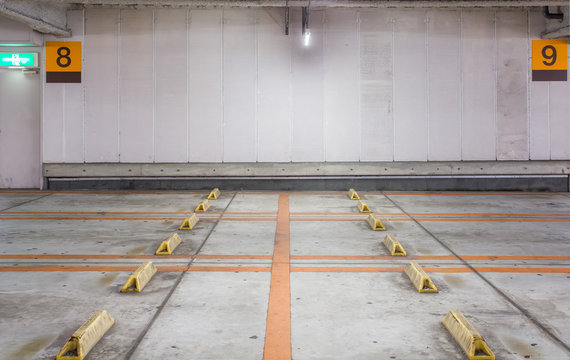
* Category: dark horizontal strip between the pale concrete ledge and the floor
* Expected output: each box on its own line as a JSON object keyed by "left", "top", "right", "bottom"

{"left": 44, "top": 175, "right": 570, "bottom": 192}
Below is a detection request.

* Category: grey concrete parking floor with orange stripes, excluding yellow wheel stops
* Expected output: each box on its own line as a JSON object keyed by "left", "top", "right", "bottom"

{"left": 0, "top": 189, "right": 570, "bottom": 360}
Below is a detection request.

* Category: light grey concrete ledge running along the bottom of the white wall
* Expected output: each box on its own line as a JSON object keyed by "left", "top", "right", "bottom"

{"left": 43, "top": 160, "right": 570, "bottom": 178}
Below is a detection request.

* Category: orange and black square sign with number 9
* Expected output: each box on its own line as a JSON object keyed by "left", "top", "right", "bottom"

{"left": 532, "top": 40, "right": 568, "bottom": 81}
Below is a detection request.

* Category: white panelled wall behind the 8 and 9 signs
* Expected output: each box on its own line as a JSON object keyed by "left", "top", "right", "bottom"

{"left": 43, "top": 9, "right": 570, "bottom": 163}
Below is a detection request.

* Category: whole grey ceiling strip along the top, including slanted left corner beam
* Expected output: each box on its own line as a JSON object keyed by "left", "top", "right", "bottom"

{"left": 0, "top": 0, "right": 568, "bottom": 37}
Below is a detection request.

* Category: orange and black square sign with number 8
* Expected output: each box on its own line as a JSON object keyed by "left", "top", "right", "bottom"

{"left": 46, "top": 41, "right": 81, "bottom": 83}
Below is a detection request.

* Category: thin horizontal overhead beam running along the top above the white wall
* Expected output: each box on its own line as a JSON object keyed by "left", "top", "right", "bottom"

{"left": 40, "top": 0, "right": 568, "bottom": 8}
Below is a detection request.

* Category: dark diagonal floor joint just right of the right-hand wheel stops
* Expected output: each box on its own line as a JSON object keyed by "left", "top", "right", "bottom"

{"left": 382, "top": 192, "right": 570, "bottom": 353}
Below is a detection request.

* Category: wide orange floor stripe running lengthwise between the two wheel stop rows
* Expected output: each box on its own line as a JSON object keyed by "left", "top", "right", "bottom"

{"left": 263, "top": 194, "right": 291, "bottom": 360}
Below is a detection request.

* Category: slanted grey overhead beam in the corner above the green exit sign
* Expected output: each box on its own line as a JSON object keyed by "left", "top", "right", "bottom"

{"left": 0, "top": 0, "right": 71, "bottom": 37}
